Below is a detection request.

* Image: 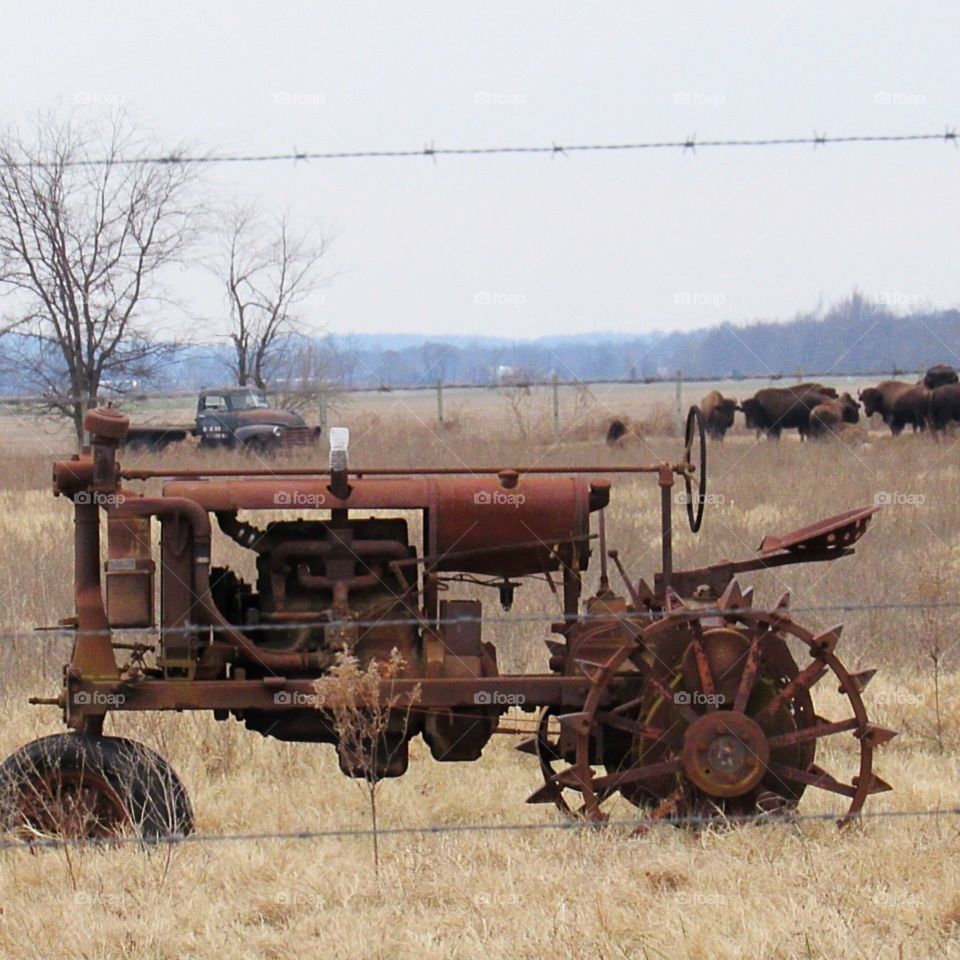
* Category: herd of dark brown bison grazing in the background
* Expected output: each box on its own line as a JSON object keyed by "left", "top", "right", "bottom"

{"left": 607, "top": 364, "right": 960, "bottom": 443}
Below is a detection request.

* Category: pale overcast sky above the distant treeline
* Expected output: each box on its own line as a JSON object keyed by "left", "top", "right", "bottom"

{"left": 0, "top": 0, "right": 960, "bottom": 338}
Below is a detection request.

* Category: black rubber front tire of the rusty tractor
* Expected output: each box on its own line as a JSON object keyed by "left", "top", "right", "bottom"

{"left": 0, "top": 733, "right": 193, "bottom": 840}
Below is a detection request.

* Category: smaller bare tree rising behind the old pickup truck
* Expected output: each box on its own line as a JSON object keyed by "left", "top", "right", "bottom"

{"left": 210, "top": 205, "right": 330, "bottom": 389}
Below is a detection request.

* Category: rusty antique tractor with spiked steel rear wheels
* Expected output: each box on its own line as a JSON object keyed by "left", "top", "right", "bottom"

{"left": 0, "top": 407, "right": 894, "bottom": 838}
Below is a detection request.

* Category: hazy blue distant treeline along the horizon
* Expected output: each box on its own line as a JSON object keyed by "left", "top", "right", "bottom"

{"left": 0, "top": 294, "right": 960, "bottom": 394}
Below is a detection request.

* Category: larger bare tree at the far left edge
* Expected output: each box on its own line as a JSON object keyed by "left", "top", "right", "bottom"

{"left": 0, "top": 115, "right": 198, "bottom": 440}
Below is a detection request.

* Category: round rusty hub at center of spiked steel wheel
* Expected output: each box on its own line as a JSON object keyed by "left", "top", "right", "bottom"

{"left": 681, "top": 710, "right": 770, "bottom": 797}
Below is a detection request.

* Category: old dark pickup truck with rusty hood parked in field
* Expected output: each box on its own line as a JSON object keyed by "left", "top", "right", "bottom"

{"left": 124, "top": 387, "right": 320, "bottom": 451}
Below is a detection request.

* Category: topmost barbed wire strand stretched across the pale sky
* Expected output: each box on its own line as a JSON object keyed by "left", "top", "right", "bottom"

{"left": 4, "top": 127, "right": 957, "bottom": 169}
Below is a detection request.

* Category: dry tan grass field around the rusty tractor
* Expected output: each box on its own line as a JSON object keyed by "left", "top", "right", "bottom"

{"left": 0, "top": 396, "right": 960, "bottom": 960}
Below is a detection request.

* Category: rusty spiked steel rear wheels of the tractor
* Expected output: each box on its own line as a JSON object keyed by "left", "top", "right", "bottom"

{"left": 531, "top": 607, "right": 895, "bottom": 825}
